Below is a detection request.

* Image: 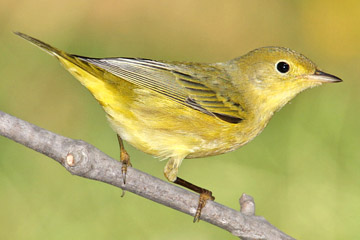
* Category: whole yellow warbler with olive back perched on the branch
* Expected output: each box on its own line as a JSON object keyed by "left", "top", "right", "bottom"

{"left": 16, "top": 32, "right": 341, "bottom": 221}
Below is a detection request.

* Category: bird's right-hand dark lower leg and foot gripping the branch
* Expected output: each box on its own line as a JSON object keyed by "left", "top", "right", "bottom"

{"left": 174, "top": 177, "right": 215, "bottom": 223}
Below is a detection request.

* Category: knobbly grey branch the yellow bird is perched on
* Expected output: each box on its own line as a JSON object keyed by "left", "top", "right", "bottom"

{"left": 0, "top": 111, "right": 293, "bottom": 240}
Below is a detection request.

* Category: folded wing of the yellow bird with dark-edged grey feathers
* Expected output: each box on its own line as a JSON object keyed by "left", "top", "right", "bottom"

{"left": 77, "top": 55, "right": 242, "bottom": 123}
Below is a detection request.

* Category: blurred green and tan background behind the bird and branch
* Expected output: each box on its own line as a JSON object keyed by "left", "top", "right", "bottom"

{"left": 0, "top": 0, "right": 360, "bottom": 239}
